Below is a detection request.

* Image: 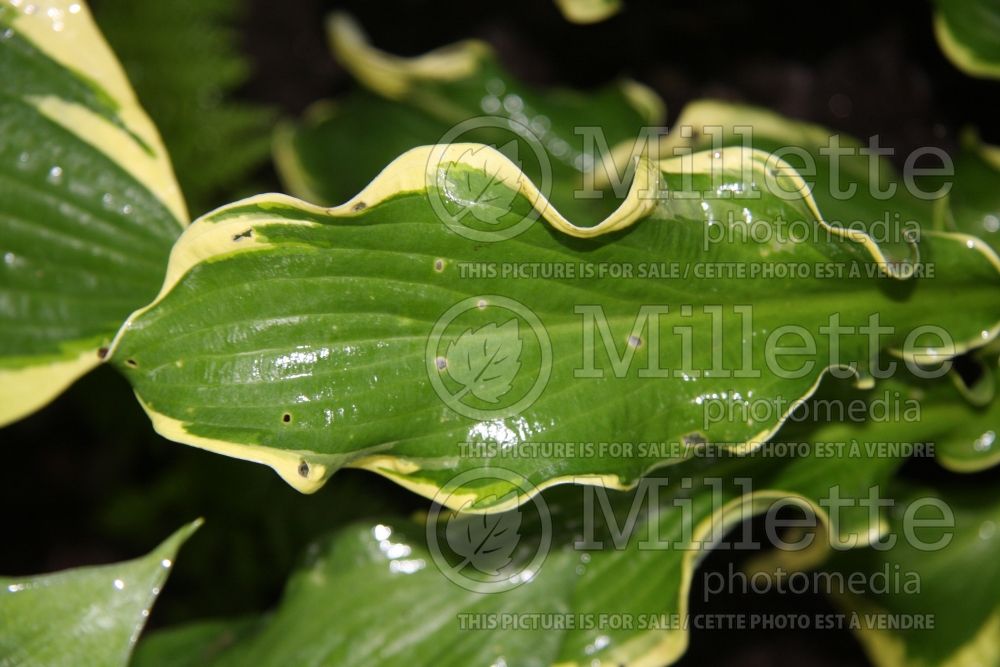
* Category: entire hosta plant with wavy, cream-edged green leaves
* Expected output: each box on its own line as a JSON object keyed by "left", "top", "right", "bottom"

{"left": 0, "top": 0, "right": 1000, "bottom": 665}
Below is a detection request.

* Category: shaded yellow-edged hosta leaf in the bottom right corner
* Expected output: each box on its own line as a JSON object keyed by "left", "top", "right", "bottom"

{"left": 829, "top": 486, "right": 1000, "bottom": 667}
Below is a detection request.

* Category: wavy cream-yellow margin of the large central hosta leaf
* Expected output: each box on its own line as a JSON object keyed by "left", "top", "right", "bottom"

{"left": 108, "top": 144, "right": 1000, "bottom": 512}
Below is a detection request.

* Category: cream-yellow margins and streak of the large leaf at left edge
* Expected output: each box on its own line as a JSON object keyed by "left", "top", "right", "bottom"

{"left": 0, "top": 0, "right": 188, "bottom": 426}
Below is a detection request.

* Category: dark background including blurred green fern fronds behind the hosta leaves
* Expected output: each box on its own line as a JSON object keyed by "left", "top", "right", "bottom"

{"left": 0, "top": 0, "right": 998, "bottom": 664}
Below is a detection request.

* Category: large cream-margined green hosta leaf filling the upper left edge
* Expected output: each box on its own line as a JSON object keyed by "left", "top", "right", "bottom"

{"left": 0, "top": 0, "right": 187, "bottom": 424}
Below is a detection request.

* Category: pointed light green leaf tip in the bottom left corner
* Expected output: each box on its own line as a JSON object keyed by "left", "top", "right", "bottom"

{"left": 0, "top": 520, "right": 201, "bottom": 667}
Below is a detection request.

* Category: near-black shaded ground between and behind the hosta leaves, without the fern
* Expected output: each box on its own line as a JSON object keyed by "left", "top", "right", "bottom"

{"left": 0, "top": 0, "right": 1000, "bottom": 667}
